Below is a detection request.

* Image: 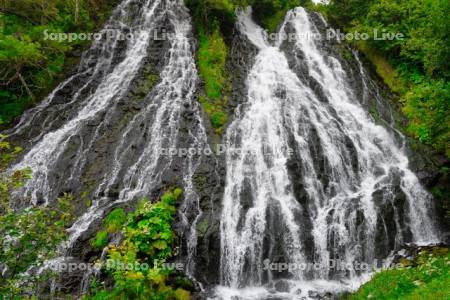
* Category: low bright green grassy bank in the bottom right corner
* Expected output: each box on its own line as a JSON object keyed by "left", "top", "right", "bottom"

{"left": 344, "top": 248, "right": 450, "bottom": 300}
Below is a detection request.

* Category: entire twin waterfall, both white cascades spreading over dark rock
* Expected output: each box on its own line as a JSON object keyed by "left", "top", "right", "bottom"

{"left": 1, "top": 0, "right": 439, "bottom": 300}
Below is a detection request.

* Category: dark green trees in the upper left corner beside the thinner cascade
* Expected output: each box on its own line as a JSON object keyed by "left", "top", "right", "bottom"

{"left": 0, "top": 0, "right": 114, "bottom": 124}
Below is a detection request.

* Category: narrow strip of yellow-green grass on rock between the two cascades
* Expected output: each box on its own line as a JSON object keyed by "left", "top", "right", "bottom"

{"left": 198, "top": 29, "right": 229, "bottom": 134}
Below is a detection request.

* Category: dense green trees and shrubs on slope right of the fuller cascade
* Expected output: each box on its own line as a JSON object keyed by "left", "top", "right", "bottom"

{"left": 321, "top": 0, "right": 450, "bottom": 157}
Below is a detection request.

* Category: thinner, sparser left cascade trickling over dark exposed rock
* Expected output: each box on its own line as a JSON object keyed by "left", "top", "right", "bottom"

{"left": 8, "top": 0, "right": 208, "bottom": 292}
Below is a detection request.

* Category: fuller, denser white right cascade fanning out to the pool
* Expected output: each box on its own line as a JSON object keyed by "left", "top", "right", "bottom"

{"left": 216, "top": 8, "right": 438, "bottom": 299}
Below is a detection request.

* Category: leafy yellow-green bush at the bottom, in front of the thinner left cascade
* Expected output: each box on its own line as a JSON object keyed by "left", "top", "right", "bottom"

{"left": 89, "top": 188, "right": 190, "bottom": 300}
